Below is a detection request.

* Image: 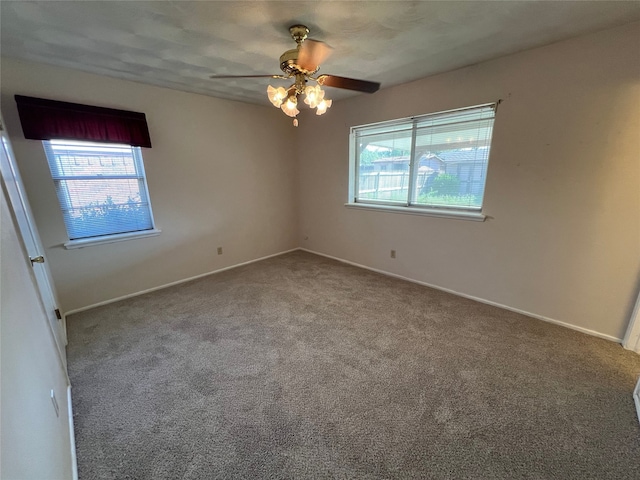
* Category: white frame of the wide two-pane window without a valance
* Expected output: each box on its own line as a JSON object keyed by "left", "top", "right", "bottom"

{"left": 345, "top": 100, "right": 500, "bottom": 222}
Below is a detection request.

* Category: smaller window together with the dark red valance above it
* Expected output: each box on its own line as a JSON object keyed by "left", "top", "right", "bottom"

{"left": 15, "top": 95, "right": 160, "bottom": 248}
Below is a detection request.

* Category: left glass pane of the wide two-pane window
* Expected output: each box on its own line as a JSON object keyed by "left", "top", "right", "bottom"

{"left": 356, "top": 129, "right": 411, "bottom": 204}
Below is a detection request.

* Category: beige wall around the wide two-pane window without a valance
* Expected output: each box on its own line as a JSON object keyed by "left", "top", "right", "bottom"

{"left": 298, "top": 23, "right": 640, "bottom": 339}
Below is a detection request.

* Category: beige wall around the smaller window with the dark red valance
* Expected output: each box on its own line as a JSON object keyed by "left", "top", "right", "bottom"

{"left": 1, "top": 58, "right": 298, "bottom": 311}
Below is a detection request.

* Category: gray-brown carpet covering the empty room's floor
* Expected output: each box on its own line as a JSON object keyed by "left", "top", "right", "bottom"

{"left": 68, "top": 251, "right": 640, "bottom": 480}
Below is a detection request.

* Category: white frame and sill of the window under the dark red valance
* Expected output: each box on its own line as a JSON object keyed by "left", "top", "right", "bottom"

{"left": 42, "top": 139, "right": 161, "bottom": 249}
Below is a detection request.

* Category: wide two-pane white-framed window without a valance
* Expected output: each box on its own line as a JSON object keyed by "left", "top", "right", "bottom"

{"left": 347, "top": 103, "right": 497, "bottom": 219}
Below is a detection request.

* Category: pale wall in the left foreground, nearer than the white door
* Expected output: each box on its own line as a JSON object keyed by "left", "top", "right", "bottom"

{"left": 0, "top": 182, "right": 72, "bottom": 480}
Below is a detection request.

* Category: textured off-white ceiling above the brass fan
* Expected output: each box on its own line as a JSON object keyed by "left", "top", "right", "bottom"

{"left": 0, "top": 0, "right": 640, "bottom": 105}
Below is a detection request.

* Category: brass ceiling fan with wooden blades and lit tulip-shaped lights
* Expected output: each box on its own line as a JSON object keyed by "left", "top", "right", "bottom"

{"left": 210, "top": 25, "right": 380, "bottom": 127}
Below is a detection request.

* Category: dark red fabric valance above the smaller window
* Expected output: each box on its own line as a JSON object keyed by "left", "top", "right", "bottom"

{"left": 15, "top": 95, "right": 151, "bottom": 148}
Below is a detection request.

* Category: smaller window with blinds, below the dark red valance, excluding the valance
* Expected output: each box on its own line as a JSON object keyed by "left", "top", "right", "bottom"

{"left": 43, "top": 140, "right": 159, "bottom": 244}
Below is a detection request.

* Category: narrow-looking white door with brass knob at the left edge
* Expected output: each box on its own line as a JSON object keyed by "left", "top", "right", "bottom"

{"left": 0, "top": 115, "right": 67, "bottom": 366}
